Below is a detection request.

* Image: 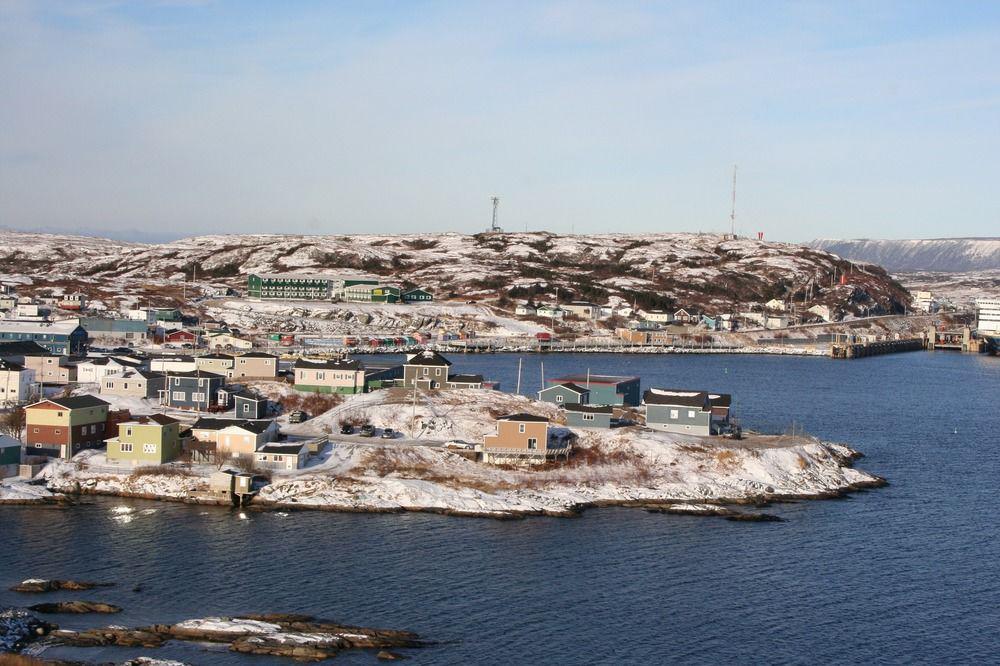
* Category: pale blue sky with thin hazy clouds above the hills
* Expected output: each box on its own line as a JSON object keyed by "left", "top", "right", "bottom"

{"left": 0, "top": 0, "right": 1000, "bottom": 241}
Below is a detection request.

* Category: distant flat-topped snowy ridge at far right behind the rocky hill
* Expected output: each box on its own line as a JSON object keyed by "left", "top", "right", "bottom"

{"left": 809, "top": 238, "right": 1000, "bottom": 272}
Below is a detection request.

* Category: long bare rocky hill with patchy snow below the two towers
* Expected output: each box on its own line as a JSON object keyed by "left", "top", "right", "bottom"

{"left": 0, "top": 232, "right": 909, "bottom": 312}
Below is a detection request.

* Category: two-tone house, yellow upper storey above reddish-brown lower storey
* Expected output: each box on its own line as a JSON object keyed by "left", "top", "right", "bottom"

{"left": 24, "top": 395, "right": 108, "bottom": 460}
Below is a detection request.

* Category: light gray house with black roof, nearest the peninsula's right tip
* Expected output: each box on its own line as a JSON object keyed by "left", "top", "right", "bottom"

{"left": 642, "top": 389, "right": 732, "bottom": 435}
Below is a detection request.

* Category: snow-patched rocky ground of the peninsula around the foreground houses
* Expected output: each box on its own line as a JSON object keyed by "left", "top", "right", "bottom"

{"left": 42, "top": 390, "right": 879, "bottom": 516}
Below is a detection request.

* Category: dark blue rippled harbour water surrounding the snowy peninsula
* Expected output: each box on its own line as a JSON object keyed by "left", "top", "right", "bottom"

{"left": 0, "top": 352, "right": 1000, "bottom": 664}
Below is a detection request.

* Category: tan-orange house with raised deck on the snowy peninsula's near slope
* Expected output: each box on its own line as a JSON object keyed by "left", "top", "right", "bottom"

{"left": 483, "top": 414, "right": 571, "bottom": 463}
